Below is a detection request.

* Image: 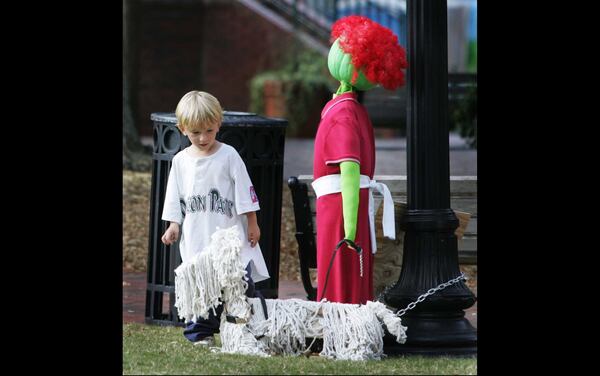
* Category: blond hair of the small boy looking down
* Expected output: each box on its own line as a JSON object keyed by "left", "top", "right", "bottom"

{"left": 175, "top": 90, "right": 223, "bottom": 132}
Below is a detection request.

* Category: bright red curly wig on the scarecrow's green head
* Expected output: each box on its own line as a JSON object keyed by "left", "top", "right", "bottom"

{"left": 331, "top": 16, "right": 407, "bottom": 90}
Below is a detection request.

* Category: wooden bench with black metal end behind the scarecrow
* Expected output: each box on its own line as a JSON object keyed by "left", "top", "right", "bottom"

{"left": 288, "top": 175, "right": 477, "bottom": 300}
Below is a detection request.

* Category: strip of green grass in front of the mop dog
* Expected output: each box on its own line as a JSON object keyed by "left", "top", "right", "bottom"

{"left": 123, "top": 324, "right": 477, "bottom": 375}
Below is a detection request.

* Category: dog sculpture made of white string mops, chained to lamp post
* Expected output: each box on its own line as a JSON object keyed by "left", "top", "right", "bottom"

{"left": 175, "top": 226, "right": 406, "bottom": 360}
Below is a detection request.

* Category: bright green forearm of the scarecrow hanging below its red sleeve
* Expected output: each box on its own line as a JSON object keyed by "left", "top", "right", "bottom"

{"left": 340, "top": 161, "right": 360, "bottom": 241}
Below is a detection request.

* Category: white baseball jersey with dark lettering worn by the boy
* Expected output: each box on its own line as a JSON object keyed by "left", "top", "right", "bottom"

{"left": 162, "top": 143, "right": 269, "bottom": 282}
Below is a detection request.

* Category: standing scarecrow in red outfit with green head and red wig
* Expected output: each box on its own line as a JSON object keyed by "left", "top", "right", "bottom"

{"left": 312, "top": 16, "right": 407, "bottom": 304}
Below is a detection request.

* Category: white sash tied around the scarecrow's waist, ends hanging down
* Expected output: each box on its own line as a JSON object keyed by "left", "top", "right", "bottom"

{"left": 312, "top": 174, "right": 396, "bottom": 253}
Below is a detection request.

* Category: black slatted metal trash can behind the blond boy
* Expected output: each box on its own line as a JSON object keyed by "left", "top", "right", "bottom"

{"left": 145, "top": 111, "right": 288, "bottom": 325}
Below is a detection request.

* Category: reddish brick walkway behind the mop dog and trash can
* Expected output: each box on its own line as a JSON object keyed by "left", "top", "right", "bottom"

{"left": 123, "top": 271, "right": 477, "bottom": 327}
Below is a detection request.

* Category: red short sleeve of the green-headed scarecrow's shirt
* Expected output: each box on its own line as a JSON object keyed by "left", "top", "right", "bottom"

{"left": 323, "top": 116, "right": 360, "bottom": 165}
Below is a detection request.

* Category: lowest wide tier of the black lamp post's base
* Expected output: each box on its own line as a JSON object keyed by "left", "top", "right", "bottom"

{"left": 383, "top": 315, "right": 477, "bottom": 356}
